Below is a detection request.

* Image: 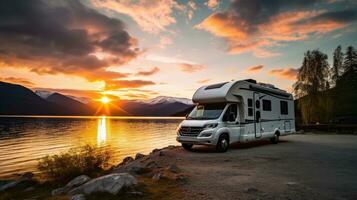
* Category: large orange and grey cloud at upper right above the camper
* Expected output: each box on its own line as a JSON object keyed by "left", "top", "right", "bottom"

{"left": 196, "top": 0, "right": 357, "bottom": 57}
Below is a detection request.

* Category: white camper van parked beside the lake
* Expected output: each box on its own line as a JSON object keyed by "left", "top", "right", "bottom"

{"left": 177, "top": 79, "right": 295, "bottom": 152}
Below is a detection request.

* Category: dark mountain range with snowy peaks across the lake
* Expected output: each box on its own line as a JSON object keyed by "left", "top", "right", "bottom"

{"left": 0, "top": 81, "right": 193, "bottom": 116}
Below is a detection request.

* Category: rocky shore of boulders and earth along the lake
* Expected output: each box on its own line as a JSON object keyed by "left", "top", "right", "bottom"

{"left": 0, "top": 146, "right": 187, "bottom": 200}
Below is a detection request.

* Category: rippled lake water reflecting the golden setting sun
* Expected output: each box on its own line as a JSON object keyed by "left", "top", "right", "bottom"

{"left": 0, "top": 117, "right": 183, "bottom": 177}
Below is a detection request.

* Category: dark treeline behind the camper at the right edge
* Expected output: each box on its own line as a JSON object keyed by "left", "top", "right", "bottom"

{"left": 293, "top": 46, "right": 357, "bottom": 124}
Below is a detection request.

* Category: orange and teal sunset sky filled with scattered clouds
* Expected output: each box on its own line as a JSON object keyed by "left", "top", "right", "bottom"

{"left": 0, "top": 0, "right": 357, "bottom": 99}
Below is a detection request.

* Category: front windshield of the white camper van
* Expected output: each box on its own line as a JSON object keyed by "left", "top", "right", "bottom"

{"left": 187, "top": 103, "right": 226, "bottom": 120}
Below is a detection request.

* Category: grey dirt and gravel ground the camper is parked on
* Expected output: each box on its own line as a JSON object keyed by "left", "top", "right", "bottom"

{"left": 166, "top": 134, "right": 357, "bottom": 199}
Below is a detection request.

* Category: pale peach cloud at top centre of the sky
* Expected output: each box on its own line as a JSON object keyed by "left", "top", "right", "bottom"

{"left": 92, "top": 0, "right": 183, "bottom": 33}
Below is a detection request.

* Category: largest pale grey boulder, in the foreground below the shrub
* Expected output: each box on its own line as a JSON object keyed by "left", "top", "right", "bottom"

{"left": 69, "top": 173, "right": 137, "bottom": 195}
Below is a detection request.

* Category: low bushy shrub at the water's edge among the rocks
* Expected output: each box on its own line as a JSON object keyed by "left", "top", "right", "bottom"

{"left": 38, "top": 145, "right": 112, "bottom": 181}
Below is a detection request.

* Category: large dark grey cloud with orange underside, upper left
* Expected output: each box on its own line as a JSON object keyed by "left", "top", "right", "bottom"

{"left": 0, "top": 0, "right": 139, "bottom": 81}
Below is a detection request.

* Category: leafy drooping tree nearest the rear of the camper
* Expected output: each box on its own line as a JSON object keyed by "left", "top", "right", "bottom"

{"left": 293, "top": 50, "right": 331, "bottom": 124}
